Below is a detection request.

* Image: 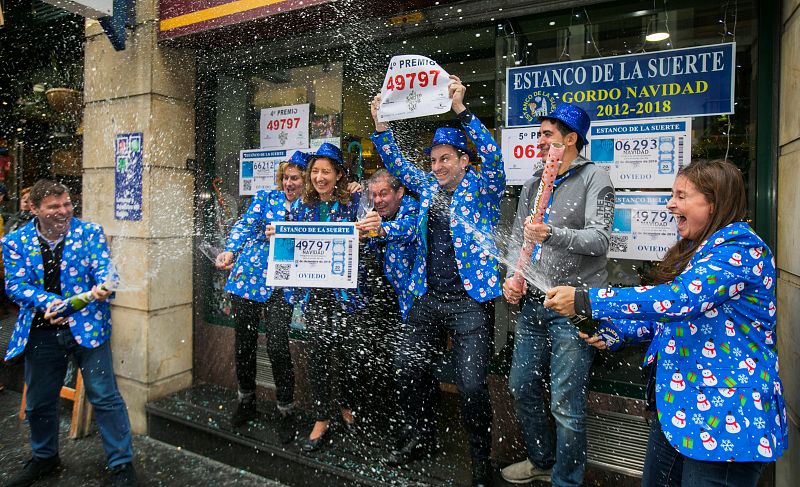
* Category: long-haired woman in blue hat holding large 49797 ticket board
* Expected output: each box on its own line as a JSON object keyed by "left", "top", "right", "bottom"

{"left": 266, "top": 143, "right": 366, "bottom": 452}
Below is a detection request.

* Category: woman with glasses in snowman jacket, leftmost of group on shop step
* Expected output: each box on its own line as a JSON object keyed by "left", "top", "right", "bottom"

{"left": 216, "top": 151, "right": 309, "bottom": 443}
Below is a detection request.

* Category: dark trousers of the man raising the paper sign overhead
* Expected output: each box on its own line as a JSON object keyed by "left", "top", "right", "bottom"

{"left": 394, "top": 291, "right": 492, "bottom": 459}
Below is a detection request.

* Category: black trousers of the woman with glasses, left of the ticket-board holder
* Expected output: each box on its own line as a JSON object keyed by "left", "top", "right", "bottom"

{"left": 231, "top": 289, "right": 294, "bottom": 406}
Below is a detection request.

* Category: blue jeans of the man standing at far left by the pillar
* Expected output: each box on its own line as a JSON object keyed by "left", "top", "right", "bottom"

{"left": 25, "top": 329, "right": 133, "bottom": 468}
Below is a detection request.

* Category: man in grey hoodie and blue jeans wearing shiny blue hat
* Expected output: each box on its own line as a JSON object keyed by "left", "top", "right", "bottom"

{"left": 502, "top": 103, "right": 614, "bottom": 487}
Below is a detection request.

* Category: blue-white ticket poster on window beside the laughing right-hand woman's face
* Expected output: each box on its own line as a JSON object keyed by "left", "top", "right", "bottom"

{"left": 608, "top": 191, "right": 678, "bottom": 261}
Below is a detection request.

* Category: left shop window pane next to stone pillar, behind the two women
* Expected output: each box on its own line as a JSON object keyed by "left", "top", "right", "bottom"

{"left": 202, "top": 60, "right": 342, "bottom": 325}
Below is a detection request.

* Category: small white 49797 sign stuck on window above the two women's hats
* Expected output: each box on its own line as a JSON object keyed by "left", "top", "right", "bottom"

{"left": 260, "top": 103, "right": 309, "bottom": 149}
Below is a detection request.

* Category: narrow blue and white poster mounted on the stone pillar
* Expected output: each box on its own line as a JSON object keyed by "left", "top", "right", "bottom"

{"left": 114, "top": 132, "right": 142, "bottom": 220}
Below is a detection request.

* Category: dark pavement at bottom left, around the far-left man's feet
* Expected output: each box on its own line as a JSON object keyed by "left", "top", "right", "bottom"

{"left": 0, "top": 389, "right": 282, "bottom": 487}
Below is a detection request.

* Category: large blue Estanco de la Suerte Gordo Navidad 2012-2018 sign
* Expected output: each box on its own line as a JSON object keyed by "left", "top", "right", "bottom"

{"left": 506, "top": 42, "right": 736, "bottom": 127}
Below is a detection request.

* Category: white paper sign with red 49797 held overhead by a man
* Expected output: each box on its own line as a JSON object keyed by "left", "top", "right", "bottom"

{"left": 378, "top": 54, "right": 453, "bottom": 122}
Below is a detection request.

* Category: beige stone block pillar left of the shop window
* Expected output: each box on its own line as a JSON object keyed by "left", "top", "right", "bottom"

{"left": 83, "top": 5, "right": 195, "bottom": 433}
